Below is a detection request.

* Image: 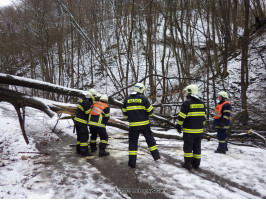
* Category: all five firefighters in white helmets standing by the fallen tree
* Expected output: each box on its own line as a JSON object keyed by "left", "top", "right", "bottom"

{"left": 74, "top": 83, "right": 232, "bottom": 170}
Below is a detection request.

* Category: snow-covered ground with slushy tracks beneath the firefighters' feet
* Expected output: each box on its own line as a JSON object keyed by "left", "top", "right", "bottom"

{"left": 0, "top": 102, "right": 266, "bottom": 199}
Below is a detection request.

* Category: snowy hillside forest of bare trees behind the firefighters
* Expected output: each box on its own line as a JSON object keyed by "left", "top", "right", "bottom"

{"left": 0, "top": 0, "right": 266, "bottom": 130}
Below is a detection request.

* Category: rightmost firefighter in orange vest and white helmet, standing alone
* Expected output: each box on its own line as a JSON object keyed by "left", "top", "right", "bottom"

{"left": 213, "top": 91, "right": 232, "bottom": 154}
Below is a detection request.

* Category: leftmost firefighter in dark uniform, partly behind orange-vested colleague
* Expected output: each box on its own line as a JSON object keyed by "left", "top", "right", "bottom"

{"left": 74, "top": 89, "right": 97, "bottom": 156}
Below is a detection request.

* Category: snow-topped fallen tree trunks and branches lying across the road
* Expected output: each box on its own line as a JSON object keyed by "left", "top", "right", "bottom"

{"left": 0, "top": 73, "right": 265, "bottom": 144}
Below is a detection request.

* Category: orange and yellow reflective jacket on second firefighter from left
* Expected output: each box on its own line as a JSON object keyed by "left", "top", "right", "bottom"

{"left": 88, "top": 101, "right": 110, "bottom": 128}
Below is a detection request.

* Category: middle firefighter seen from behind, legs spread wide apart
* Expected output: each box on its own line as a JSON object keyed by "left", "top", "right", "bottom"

{"left": 122, "top": 83, "right": 160, "bottom": 168}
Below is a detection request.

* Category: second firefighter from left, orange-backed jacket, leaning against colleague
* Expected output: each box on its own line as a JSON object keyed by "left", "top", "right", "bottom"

{"left": 88, "top": 95, "right": 110, "bottom": 157}
